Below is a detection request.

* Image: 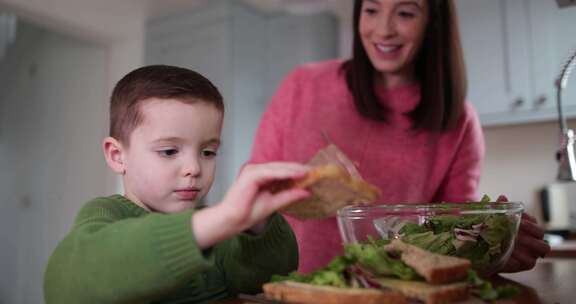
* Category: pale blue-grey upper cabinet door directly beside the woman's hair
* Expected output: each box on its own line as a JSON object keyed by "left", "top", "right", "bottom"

{"left": 457, "top": 0, "right": 518, "bottom": 121}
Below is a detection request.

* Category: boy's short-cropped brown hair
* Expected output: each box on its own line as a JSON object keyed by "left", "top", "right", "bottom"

{"left": 110, "top": 65, "right": 224, "bottom": 145}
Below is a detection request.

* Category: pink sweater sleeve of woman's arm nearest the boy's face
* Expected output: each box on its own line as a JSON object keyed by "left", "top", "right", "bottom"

{"left": 250, "top": 69, "right": 300, "bottom": 163}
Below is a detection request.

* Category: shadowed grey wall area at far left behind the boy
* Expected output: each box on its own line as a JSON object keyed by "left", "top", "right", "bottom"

{"left": 0, "top": 21, "right": 108, "bottom": 303}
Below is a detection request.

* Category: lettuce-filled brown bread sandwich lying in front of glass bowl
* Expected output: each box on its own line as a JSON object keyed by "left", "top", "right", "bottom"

{"left": 263, "top": 239, "right": 513, "bottom": 304}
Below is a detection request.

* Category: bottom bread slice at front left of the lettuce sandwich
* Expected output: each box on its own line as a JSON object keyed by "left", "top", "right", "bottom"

{"left": 262, "top": 281, "right": 407, "bottom": 304}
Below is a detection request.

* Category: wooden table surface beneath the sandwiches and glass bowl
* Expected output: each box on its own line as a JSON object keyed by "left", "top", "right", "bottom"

{"left": 218, "top": 258, "right": 576, "bottom": 304}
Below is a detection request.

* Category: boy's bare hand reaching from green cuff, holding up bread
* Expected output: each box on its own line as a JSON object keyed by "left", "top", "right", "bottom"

{"left": 192, "top": 162, "right": 310, "bottom": 248}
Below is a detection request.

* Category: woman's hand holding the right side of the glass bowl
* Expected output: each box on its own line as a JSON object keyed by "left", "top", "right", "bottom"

{"left": 497, "top": 196, "right": 550, "bottom": 272}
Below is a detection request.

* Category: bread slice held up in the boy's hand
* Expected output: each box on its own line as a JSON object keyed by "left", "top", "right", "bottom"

{"left": 271, "top": 144, "right": 380, "bottom": 220}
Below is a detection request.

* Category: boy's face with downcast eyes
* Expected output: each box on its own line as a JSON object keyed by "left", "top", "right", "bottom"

{"left": 122, "top": 98, "right": 223, "bottom": 213}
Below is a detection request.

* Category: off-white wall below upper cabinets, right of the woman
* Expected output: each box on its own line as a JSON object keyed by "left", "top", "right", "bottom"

{"left": 480, "top": 121, "right": 576, "bottom": 216}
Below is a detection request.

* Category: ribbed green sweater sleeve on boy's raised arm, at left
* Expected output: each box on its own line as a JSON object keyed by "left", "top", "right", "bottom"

{"left": 44, "top": 201, "right": 210, "bottom": 304}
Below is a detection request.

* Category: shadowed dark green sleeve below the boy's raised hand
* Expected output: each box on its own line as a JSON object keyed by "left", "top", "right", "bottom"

{"left": 216, "top": 214, "right": 298, "bottom": 294}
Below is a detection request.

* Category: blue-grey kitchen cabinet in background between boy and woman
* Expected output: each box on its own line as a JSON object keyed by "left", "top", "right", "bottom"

{"left": 145, "top": 0, "right": 338, "bottom": 201}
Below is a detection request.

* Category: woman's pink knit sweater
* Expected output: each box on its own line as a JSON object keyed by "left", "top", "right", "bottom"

{"left": 251, "top": 61, "right": 484, "bottom": 272}
